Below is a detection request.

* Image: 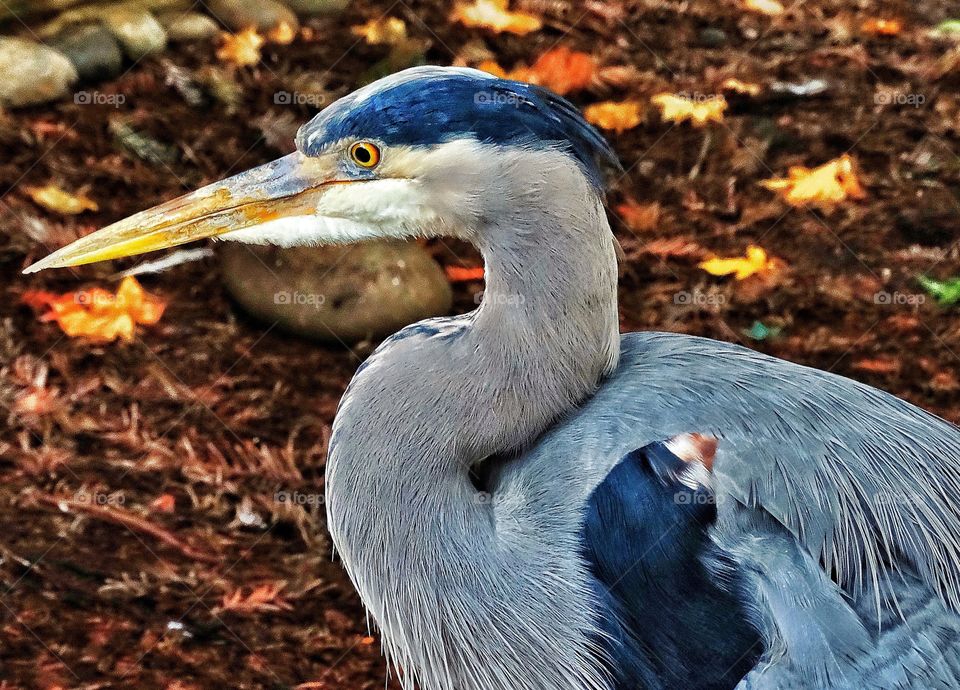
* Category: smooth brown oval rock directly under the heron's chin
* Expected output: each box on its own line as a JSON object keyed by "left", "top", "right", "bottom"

{"left": 217, "top": 242, "right": 452, "bottom": 343}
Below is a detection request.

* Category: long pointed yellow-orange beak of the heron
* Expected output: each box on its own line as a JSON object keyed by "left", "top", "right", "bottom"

{"left": 23, "top": 153, "right": 338, "bottom": 273}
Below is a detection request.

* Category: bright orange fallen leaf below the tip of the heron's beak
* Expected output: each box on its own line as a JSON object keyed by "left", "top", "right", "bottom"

{"left": 21, "top": 276, "right": 166, "bottom": 342}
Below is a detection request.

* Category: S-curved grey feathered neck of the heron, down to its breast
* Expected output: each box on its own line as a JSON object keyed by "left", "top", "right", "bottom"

{"left": 326, "top": 156, "right": 619, "bottom": 690}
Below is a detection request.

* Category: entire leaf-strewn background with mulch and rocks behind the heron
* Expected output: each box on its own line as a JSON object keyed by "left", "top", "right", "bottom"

{"left": 0, "top": 0, "right": 960, "bottom": 690}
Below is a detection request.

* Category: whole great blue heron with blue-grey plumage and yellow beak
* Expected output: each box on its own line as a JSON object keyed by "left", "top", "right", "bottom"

{"left": 28, "top": 67, "right": 960, "bottom": 690}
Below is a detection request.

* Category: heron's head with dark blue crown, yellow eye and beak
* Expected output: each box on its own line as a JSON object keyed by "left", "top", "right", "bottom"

{"left": 25, "top": 67, "right": 616, "bottom": 272}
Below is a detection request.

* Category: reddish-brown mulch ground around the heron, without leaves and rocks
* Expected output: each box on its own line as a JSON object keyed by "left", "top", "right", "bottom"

{"left": 0, "top": 0, "right": 960, "bottom": 690}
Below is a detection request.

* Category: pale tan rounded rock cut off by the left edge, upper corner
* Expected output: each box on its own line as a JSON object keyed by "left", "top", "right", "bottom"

{"left": 0, "top": 36, "right": 77, "bottom": 107}
